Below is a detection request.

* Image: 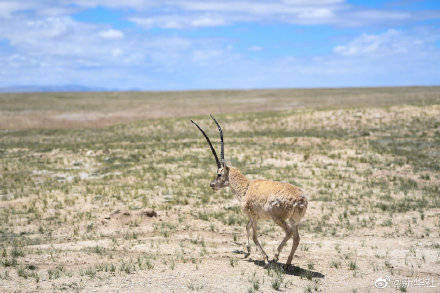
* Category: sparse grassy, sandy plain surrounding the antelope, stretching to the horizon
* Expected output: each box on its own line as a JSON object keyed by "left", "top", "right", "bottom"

{"left": 0, "top": 87, "right": 440, "bottom": 292}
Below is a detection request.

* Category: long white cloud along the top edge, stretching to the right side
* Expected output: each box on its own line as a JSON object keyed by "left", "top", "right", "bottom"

{"left": 161, "top": 0, "right": 426, "bottom": 28}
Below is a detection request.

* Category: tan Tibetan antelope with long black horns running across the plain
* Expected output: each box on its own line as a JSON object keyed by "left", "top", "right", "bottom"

{"left": 191, "top": 115, "right": 307, "bottom": 267}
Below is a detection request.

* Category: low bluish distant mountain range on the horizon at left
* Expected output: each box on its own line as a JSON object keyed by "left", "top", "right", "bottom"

{"left": 0, "top": 85, "right": 113, "bottom": 93}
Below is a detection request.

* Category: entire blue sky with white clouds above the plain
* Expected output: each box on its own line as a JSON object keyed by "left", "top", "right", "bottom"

{"left": 0, "top": 0, "right": 440, "bottom": 90}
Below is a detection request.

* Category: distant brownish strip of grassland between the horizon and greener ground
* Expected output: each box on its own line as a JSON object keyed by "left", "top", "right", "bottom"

{"left": 0, "top": 87, "right": 440, "bottom": 129}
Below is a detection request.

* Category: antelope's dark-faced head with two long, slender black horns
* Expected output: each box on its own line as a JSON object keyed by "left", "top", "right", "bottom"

{"left": 191, "top": 115, "right": 229, "bottom": 191}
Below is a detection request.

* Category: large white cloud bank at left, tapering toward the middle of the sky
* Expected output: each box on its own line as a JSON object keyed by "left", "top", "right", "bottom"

{"left": 0, "top": 17, "right": 191, "bottom": 68}
